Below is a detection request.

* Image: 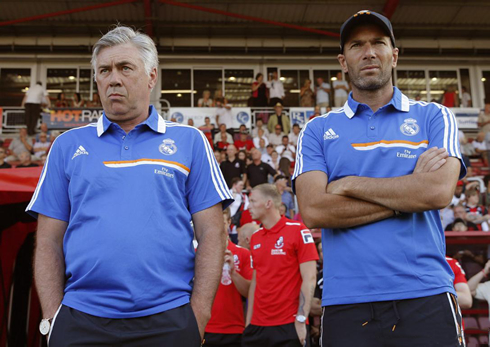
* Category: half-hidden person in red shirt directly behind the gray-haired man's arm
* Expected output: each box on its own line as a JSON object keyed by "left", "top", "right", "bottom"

{"left": 204, "top": 208, "right": 252, "bottom": 347}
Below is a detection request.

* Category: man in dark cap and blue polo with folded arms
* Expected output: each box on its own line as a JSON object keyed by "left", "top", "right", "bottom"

{"left": 293, "top": 11, "right": 466, "bottom": 347}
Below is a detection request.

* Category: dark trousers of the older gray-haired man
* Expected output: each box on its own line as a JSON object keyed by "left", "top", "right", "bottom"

{"left": 49, "top": 304, "right": 201, "bottom": 347}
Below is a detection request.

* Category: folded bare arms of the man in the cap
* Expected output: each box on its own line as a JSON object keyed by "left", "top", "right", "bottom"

{"left": 295, "top": 147, "right": 461, "bottom": 228}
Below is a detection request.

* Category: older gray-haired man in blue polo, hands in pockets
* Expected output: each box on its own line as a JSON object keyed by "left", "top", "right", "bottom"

{"left": 27, "top": 27, "right": 232, "bottom": 347}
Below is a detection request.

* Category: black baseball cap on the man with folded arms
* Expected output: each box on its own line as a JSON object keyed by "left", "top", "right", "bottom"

{"left": 340, "top": 10, "right": 396, "bottom": 53}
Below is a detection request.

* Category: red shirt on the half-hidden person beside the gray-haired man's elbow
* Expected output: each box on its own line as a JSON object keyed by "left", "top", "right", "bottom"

{"left": 205, "top": 241, "right": 252, "bottom": 334}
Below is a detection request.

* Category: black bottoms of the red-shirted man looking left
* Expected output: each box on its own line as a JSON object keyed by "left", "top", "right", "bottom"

{"left": 242, "top": 323, "right": 310, "bottom": 347}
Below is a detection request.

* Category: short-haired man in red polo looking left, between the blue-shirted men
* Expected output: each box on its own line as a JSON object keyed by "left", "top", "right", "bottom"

{"left": 242, "top": 184, "right": 318, "bottom": 347}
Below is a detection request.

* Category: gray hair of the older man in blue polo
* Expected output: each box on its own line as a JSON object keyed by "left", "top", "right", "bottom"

{"left": 91, "top": 26, "right": 158, "bottom": 78}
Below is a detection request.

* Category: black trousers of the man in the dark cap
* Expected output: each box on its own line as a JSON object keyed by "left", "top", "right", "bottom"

{"left": 320, "top": 293, "right": 465, "bottom": 347}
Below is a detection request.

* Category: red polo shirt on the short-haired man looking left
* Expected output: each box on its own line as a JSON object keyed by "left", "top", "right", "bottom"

{"left": 250, "top": 217, "right": 318, "bottom": 326}
